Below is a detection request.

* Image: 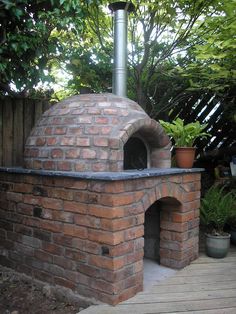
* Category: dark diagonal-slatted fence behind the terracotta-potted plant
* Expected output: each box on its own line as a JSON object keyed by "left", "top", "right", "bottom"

{"left": 169, "top": 93, "right": 236, "bottom": 153}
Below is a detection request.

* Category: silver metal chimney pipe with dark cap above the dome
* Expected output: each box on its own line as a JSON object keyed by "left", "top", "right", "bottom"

{"left": 108, "top": 1, "right": 135, "bottom": 97}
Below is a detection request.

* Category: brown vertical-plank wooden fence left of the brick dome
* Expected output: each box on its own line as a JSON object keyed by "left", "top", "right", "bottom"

{"left": 0, "top": 97, "right": 49, "bottom": 167}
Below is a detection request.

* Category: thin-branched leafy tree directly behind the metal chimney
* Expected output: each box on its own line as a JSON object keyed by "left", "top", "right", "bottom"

{"left": 55, "top": 0, "right": 230, "bottom": 117}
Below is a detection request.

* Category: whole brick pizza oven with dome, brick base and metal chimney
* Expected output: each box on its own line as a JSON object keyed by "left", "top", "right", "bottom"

{"left": 0, "top": 2, "right": 202, "bottom": 305}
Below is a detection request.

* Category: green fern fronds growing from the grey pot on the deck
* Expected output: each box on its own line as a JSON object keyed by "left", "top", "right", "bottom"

{"left": 200, "top": 185, "right": 236, "bottom": 235}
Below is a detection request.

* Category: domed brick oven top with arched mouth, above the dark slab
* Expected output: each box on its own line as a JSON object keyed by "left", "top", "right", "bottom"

{"left": 25, "top": 94, "right": 170, "bottom": 172}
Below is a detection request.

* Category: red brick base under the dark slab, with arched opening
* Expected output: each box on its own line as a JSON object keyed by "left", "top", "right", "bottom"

{"left": 0, "top": 172, "right": 200, "bottom": 304}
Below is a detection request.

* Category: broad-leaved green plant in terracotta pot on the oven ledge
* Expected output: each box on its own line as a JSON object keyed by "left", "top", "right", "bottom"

{"left": 159, "top": 118, "right": 209, "bottom": 168}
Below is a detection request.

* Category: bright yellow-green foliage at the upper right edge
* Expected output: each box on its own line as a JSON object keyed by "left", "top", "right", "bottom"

{"left": 179, "top": 0, "right": 236, "bottom": 92}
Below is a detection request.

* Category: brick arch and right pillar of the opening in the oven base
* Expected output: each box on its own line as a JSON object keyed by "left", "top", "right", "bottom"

{"left": 141, "top": 180, "right": 198, "bottom": 269}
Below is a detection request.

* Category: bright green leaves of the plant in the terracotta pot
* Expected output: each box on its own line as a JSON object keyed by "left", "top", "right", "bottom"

{"left": 159, "top": 118, "right": 209, "bottom": 147}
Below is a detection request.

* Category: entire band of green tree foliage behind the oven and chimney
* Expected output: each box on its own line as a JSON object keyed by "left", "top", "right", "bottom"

{"left": 0, "top": 0, "right": 235, "bottom": 118}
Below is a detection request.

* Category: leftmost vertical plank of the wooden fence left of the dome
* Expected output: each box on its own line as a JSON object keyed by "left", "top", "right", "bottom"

{"left": 3, "top": 98, "right": 13, "bottom": 166}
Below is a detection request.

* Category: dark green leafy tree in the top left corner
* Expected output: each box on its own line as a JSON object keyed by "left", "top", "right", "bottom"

{"left": 0, "top": 0, "right": 96, "bottom": 95}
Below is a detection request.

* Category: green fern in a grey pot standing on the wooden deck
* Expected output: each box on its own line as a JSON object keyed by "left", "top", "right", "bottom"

{"left": 200, "top": 185, "right": 235, "bottom": 258}
